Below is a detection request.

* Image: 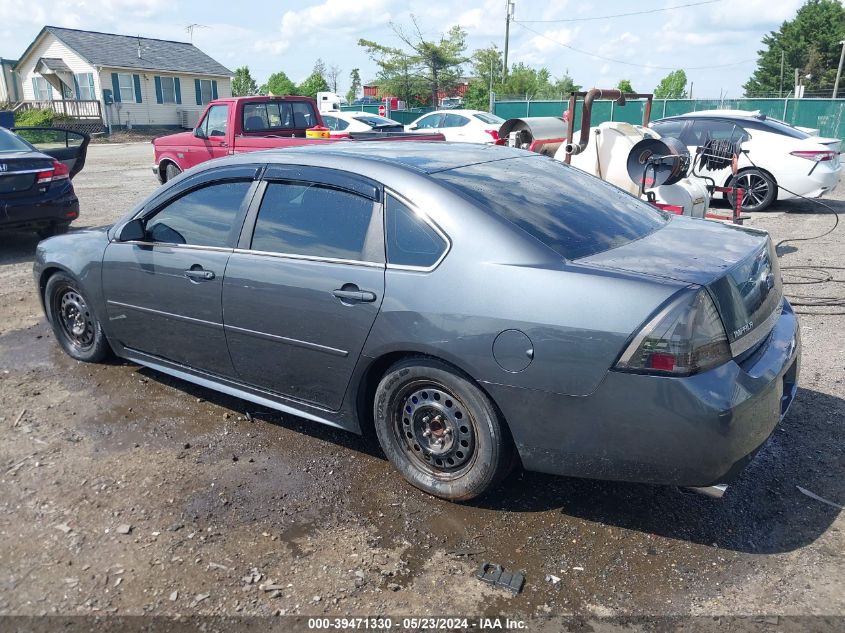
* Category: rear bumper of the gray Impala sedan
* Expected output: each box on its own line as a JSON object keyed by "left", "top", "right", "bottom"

{"left": 484, "top": 301, "right": 801, "bottom": 486}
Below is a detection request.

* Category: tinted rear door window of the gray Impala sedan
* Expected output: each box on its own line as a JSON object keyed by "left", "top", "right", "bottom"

{"left": 251, "top": 182, "right": 383, "bottom": 261}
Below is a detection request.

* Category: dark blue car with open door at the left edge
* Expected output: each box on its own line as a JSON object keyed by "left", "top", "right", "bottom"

{"left": 0, "top": 127, "right": 90, "bottom": 237}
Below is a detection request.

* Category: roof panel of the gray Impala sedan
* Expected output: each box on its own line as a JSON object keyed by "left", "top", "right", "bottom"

{"left": 256, "top": 140, "right": 538, "bottom": 174}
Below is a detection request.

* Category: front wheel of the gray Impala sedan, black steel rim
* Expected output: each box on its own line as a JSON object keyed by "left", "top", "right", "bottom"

{"left": 44, "top": 273, "right": 111, "bottom": 363}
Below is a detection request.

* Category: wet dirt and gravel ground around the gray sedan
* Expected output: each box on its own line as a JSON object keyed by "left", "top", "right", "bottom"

{"left": 0, "top": 143, "right": 845, "bottom": 622}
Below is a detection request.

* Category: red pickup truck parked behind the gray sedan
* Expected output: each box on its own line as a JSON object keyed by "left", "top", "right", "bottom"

{"left": 153, "top": 97, "right": 443, "bottom": 183}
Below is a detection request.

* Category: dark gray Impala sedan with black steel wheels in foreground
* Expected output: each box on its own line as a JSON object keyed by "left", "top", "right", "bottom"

{"left": 34, "top": 142, "right": 801, "bottom": 500}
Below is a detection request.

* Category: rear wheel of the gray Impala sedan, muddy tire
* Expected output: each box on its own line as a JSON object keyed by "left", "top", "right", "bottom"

{"left": 373, "top": 358, "right": 514, "bottom": 501}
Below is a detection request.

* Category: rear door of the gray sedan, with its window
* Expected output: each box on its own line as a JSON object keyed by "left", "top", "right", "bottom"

{"left": 223, "top": 165, "right": 385, "bottom": 410}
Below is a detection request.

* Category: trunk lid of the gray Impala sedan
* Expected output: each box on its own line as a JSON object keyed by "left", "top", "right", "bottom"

{"left": 576, "top": 218, "right": 783, "bottom": 356}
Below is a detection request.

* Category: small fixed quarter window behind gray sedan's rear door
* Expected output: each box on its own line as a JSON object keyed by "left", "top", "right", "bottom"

{"left": 385, "top": 196, "right": 447, "bottom": 268}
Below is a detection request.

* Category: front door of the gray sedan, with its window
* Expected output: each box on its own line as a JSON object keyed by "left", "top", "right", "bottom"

{"left": 102, "top": 165, "right": 259, "bottom": 376}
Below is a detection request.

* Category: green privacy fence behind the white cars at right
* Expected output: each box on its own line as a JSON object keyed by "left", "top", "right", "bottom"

{"left": 494, "top": 99, "right": 845, "bottom": 140}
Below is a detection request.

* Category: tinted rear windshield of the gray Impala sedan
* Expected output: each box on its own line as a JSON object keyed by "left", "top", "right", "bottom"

{"left": 432, "top": 155, "right": 669, "bottom": 259}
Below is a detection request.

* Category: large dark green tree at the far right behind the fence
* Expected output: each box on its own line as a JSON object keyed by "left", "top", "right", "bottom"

{"left": 743, "top": 0, "right": 845, "bottom": 97}
